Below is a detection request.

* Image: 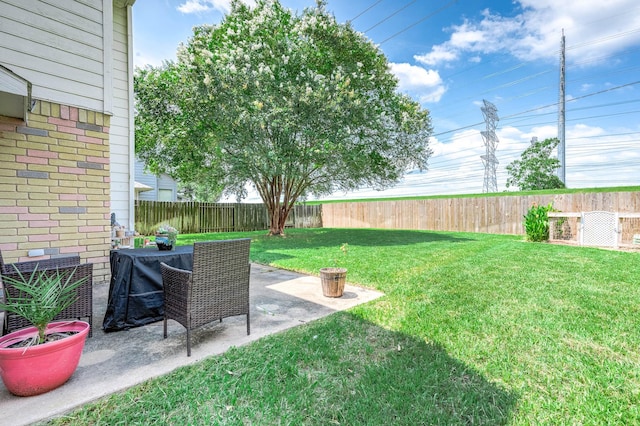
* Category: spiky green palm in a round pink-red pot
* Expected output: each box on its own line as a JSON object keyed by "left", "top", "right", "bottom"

{"left": 0, "top": 267, "right": 90, "bottom": 396}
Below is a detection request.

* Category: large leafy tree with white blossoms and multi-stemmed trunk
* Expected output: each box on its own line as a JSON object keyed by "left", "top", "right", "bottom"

{"left": 135, "top": 0, "right": 432, "bottom": 234}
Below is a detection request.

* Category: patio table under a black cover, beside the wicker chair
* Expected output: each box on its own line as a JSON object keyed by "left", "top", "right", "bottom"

{"left": 102, "top": 246, "right": 193, "bottom": 332}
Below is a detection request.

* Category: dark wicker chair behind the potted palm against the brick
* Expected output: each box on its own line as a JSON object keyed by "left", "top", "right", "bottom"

{"left": 0, "top": 253, "right": 93, "bottom": 336}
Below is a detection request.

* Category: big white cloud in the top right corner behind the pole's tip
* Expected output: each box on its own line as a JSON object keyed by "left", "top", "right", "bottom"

{"left": 415, "top": 0, "right": 640, "bottom": 66}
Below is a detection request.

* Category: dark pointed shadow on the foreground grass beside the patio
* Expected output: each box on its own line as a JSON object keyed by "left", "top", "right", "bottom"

{"left": 148, "top": 312, "right": 518, "bottom": 425}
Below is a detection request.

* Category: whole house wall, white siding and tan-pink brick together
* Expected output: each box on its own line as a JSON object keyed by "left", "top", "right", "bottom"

{"left": 0, "top": 0, "right": 135, "bottom": 282}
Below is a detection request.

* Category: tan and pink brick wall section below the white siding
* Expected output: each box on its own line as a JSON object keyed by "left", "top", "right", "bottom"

{"left": 0, "top": 101, "right": 111, "bottom": 283}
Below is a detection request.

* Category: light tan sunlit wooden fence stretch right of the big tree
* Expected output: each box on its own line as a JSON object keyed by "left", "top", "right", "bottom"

{"left": 322, "top": 192, "right": 640, "bottom": 235}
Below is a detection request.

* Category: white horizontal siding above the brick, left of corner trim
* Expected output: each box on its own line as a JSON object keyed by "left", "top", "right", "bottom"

{"left": 0, "top": 0, "right": 104, "bottom": 112}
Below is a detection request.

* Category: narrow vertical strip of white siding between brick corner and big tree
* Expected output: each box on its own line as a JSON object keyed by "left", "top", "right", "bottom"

{"left": 110, "top": 5, "right": 134, "bottom": 229}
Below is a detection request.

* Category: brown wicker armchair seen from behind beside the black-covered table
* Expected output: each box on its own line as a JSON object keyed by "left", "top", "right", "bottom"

{"left": 160, "top": 238, "right": 251, "bottom": 356}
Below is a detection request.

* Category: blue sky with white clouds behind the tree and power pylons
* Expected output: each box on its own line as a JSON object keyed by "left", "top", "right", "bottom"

{"left": 133, "top": 0, "right": 640, "bottom": 202}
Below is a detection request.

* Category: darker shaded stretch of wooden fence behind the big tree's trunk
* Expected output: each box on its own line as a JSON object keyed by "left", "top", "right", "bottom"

{"left": 135, "top": 201, "right": 322, "bottom": 235}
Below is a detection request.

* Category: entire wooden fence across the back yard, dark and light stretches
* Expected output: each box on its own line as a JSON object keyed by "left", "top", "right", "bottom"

{"left": 135, "top": 191, "right": 640, "bottom": 245}
